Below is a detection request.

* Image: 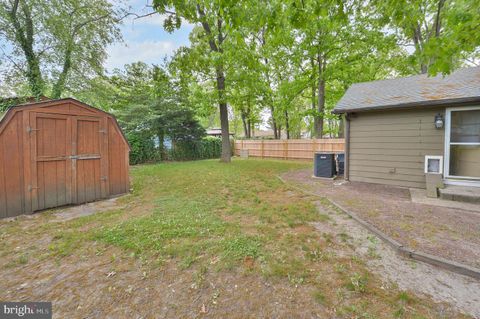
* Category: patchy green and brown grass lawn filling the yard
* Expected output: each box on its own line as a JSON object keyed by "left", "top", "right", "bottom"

{"left": 0, "top": 160, "right": 461, "bottom": 318}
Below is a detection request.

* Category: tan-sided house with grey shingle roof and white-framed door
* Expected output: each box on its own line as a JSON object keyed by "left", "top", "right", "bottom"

{"left": 334, "top": 67, "right": 480, "bottom": 188}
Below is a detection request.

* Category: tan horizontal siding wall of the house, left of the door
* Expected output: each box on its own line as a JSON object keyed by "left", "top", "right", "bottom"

{"left": 349, "top": 108, "right": 445, "bottom": 188}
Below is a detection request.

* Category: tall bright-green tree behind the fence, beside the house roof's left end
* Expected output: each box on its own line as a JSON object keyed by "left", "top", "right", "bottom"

{"left": 275, "top": 0, "right": 401, "bottom": 138}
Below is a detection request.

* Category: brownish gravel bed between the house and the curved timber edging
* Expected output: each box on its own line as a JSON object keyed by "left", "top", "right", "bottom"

{"left": 283, "top": 170, "right": 480, "bottom": 268}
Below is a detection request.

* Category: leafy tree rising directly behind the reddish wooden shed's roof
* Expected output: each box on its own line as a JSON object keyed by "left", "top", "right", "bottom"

{"left": 0, "top": 0, "right": 122, "bottom": 98}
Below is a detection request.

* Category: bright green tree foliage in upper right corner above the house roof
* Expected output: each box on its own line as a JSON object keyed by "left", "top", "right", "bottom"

{"left": 372, "top": 0, "right": 480, "bottom": 74}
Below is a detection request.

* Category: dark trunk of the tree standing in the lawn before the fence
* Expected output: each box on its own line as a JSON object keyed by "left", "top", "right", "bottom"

{"left": 217, "top": 65, "right": 232, "bottom": 163}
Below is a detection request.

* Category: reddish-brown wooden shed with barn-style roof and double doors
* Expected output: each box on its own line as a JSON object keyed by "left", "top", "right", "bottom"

{"left": 0, "top": 98, "right": 130, "bottom": 218}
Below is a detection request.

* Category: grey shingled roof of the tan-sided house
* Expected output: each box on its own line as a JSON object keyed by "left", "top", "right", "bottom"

{"left": 334, "top": 67, "right": 480, "bottom": 113}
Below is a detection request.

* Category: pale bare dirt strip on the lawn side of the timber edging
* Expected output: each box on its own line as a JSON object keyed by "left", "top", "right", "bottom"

{"left": 313, "top": 204, "right": 480, "bottom": 318}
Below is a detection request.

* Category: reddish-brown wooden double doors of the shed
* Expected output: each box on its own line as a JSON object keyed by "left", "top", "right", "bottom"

{"left": 28, "top": 113, "right": 107, "bottom": 211}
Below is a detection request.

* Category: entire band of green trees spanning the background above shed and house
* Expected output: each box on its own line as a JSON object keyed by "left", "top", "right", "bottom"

{"left": 0, "top": 0, "right": 480, "bottom": 162}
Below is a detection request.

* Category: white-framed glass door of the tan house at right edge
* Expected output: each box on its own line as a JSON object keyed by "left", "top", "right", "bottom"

{"left": 445, "top": 106, "right": 480, "bottom": 185}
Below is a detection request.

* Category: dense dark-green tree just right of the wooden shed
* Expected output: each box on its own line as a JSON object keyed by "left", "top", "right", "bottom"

{"left": 94, "top": 62, "right": 205, "bottom": 163}
